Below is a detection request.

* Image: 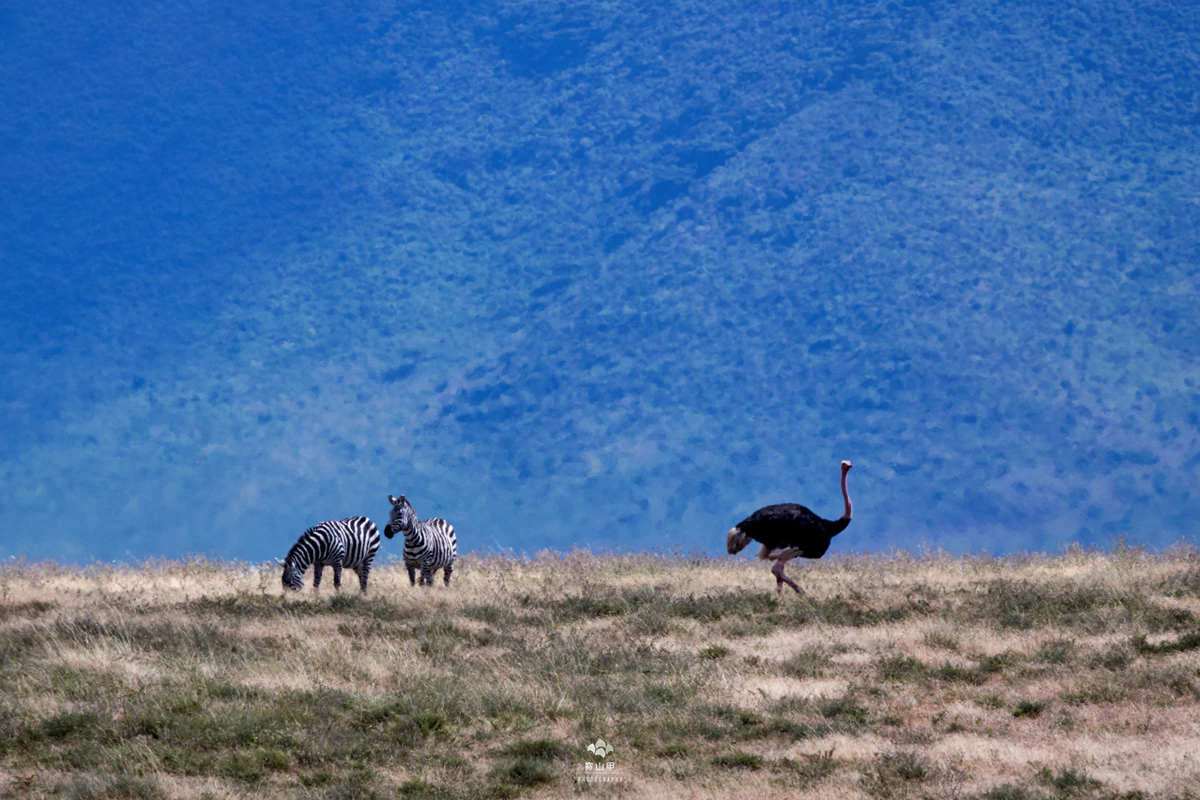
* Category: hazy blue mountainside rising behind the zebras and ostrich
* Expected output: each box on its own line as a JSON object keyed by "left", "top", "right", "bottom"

{"left": 0, "top": 0, "right": 1200, "bottom": 560}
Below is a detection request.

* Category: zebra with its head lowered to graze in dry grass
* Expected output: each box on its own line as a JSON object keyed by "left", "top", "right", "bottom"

{"left": 283, "top": 517, "right": 379, "bottom": 591}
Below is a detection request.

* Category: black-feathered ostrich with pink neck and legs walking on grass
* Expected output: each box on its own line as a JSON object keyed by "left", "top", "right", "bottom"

{"left": 725, "top": 461, "right": 852, "bottom": 594}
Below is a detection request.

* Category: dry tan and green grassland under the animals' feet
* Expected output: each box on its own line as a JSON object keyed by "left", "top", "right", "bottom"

{"left": 0, "top": 548, "right": 1200, "bottom": 800}
